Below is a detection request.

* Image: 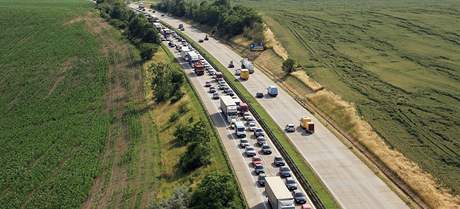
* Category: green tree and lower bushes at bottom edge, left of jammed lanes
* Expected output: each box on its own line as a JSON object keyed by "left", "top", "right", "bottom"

{"left": 149, "top": 172, "right": 238, "bottom": 209}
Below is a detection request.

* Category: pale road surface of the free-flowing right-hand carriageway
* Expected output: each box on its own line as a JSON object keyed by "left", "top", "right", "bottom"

{"left": 145, "top": 9, "right": 408, "bottom": 209}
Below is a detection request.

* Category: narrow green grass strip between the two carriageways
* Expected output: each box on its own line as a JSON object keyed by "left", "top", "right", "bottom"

{"left": 167, "top": 23, "right": 340, "bottom": 209}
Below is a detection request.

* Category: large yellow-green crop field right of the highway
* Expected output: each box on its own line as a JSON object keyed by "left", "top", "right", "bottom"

{"left": 237, "top": 0, "right": 460, "bottom": 194}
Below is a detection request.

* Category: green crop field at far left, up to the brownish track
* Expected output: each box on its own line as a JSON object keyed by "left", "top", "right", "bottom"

{"left": 0, "top": 0, "right": 109, "bottom": 209}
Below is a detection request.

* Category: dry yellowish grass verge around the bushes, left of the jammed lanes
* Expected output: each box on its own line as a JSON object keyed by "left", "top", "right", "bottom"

{"left": 131, "top": 46, "right": 245, "bottom": 208}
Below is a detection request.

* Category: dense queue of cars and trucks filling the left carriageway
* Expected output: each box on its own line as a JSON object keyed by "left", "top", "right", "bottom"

{"left": 131, "top": 5, "right": 314, "bottom": 209}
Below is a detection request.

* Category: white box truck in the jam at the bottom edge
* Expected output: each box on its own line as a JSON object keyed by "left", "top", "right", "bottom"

{"left": 265, "top": 176, "right": 295, "bottom": 209}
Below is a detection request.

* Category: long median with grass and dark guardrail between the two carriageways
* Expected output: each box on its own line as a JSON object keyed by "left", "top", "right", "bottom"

{"left": 161, "top": 21, "right": 340, "bottom": 209}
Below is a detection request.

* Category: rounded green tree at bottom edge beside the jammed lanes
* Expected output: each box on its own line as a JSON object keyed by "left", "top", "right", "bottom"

{"left": 191, "top": 172, "right": 237, "bottom": 209}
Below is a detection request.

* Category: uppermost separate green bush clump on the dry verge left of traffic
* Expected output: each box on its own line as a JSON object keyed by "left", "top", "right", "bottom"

{"left": 148, "top": 63, "right": 185, "bottom": 103}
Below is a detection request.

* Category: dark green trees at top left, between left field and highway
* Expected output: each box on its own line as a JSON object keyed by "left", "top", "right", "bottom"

{"left": 96, "top": 0, "right": 160, "bottom": 60}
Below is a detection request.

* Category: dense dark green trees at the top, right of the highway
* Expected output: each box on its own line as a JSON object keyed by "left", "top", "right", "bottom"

{"left": 154, "top": 0, "right": 263, "bottom": 41}
